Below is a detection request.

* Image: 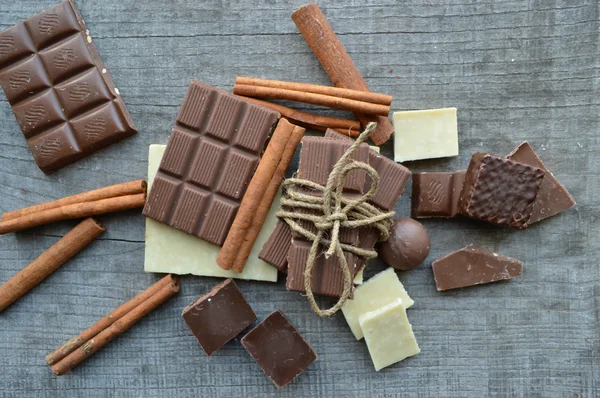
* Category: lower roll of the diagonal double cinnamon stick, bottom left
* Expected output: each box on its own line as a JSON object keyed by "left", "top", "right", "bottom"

{"left": 51, "top": 275, "right": 179, "bottom": 376}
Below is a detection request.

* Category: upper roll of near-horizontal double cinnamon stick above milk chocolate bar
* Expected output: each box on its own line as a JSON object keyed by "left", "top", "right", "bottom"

{"left": 235, "top": 76, "right": 392, "bottom": 105}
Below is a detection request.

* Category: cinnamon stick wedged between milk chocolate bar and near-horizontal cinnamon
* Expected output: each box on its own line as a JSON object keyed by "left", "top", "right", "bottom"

{"left": 243, "top": 97, "right": 360, "bottom": 137}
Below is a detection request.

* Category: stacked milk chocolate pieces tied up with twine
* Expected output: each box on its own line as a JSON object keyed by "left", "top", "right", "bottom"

{"left": 259, "top": 130, "right": 411, "bottom": 297}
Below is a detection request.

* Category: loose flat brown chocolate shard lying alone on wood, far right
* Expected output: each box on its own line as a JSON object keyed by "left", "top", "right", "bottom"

{"left": 431, "top": 245, "right": 523, "bottom": 290}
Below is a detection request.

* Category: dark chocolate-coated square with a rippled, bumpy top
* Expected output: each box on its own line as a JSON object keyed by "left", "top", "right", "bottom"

{"left": 458, "top": 152, "right": 544, "bottom": 229}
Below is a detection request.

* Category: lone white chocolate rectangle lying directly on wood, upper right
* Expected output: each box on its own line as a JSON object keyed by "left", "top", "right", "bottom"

{"left": 393, "top": 108, "right": 458, "bottom": 162}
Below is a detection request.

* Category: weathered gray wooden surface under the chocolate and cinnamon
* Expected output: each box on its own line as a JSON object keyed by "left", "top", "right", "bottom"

{"left": 0, "top": 0, "right": 600, "bottom": 397}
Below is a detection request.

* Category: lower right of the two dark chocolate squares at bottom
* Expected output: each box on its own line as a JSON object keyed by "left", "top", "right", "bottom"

{"left": 242, "top": 311, "right": 317, "bottom": 388}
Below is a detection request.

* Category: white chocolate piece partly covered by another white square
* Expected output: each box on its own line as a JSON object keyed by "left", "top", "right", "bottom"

{"left": 342, "top": 268, "right": 415, "bottom": 340}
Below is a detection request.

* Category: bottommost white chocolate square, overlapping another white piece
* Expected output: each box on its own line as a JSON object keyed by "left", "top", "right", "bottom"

{"left": 358, "top": 299, "right": 421, "bottom": 371}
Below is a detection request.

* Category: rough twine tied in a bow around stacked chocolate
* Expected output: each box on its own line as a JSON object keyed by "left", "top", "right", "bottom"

{"left": 277, "top": 123, "right": 394, "bottom": 316}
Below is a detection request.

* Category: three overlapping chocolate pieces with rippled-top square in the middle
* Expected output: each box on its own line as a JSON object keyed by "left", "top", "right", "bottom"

{"left": 412, "top": 142, "right": 575, "bottom": 229}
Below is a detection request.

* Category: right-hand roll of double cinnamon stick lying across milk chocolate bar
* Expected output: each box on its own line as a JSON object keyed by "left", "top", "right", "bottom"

{"left": 232, "top": 121, "right": 304, "bottom": 272}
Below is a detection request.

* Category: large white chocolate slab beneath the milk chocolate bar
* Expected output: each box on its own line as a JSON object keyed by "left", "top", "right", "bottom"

{"left": 144, "top": 145, "right": 281, "bottom": 282}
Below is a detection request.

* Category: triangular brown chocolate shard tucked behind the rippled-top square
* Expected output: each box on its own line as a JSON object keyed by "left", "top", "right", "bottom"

{"left": 506, "top": 141, "right": 575, "bottom": 224}
